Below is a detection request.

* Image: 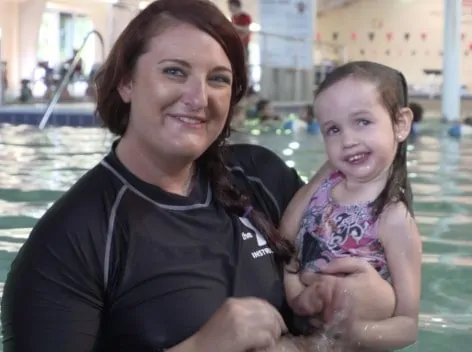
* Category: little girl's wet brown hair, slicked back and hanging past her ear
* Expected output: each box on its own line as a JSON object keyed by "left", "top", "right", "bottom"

{"left": 315, "top": 61, "right": 413, "bottom": 218}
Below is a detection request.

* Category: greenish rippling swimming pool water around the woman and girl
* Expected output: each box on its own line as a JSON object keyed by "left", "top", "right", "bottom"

{"left": 0, "top": 125, "right": 472, "bottom": 352}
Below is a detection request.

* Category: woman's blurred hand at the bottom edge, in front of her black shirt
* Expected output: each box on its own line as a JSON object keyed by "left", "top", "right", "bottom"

{"left": 185, "top": 298, "right": 287, "bottom": 352}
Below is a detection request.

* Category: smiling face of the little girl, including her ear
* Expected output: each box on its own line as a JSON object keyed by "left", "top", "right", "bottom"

{"left": 315, "top": 77, "right": 411, "bottom": 183}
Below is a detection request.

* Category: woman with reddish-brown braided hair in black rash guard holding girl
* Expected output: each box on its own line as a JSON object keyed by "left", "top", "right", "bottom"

{"left": 2, "top": 0, "right": 394, "bottom": 352}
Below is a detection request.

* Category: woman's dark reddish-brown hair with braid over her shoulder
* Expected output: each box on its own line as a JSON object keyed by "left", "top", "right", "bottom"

{"left": 95, "top": 0, "right": 292, "bottom": 260}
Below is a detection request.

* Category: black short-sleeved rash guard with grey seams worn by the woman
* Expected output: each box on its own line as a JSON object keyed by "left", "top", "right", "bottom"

{"left": 1, "top": 145, "right": 303, "bottom": 352}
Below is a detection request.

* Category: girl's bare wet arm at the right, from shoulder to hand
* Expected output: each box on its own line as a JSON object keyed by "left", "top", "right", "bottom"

{"left": 344, "top": 202, "right": 422, "bottom": 350}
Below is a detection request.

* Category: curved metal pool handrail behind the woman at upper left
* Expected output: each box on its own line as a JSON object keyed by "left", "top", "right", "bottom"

{"left": 38, "top": 30, "right": 105, "bottom": 130}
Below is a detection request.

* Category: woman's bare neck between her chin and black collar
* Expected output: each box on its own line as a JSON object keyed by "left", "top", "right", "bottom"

{"left": 115, "top": 138, "right": 195, "bottom": 196}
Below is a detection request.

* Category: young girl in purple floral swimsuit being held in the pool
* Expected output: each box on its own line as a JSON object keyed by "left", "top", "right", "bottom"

{"left": 281, "top": 62, "right": 421, "bottom": 351}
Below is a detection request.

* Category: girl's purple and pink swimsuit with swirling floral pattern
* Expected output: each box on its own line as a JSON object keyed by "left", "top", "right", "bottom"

{"left": 296, "top": 172, "right": 390, "bottom": 280}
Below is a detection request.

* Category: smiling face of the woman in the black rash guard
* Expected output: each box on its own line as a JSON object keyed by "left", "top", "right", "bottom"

{"left": 118, "top": 23, "right": 233, "bottom": 162}
